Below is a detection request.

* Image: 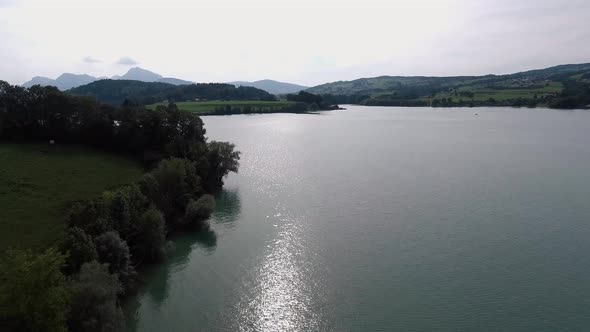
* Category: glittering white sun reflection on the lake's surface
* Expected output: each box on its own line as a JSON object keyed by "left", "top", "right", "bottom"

{"left": 239, "top": 219, "right": 322, "bottom": 331}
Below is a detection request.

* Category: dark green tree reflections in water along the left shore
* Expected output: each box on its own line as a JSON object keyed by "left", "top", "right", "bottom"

{"left": 127, "top": 190, "right": 241, "bottom": 331}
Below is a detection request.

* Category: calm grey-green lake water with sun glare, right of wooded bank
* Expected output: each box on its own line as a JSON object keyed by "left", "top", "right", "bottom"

{"left": 126, "top": 107, "right": 590, "bottom": 331}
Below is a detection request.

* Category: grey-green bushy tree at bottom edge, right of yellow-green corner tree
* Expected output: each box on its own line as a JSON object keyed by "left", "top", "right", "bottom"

{"left": 68, "top": 261, "right": 124, "bottom": 332}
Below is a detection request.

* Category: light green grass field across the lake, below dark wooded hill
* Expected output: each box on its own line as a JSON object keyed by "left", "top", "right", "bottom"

{"left": 146, "top": 100, "right": 295, "bottom": 113}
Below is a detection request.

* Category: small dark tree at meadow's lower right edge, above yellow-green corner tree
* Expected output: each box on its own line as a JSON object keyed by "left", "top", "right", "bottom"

{"left": 63, "top": 227, "right": 98, "bottom": 274}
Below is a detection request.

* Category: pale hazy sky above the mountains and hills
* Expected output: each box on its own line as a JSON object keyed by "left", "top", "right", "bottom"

{"left": 0, "top": 0, "right": 590, "bottom": 85}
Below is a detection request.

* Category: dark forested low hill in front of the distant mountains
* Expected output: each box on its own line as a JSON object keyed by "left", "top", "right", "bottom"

{"left": 68, "top": 80, "right": 275, "bottom": 105}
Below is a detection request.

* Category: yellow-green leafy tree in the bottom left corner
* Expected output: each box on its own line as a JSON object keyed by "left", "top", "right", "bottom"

{"left": 0, "top": 248, "right": 70, "bottom": 331}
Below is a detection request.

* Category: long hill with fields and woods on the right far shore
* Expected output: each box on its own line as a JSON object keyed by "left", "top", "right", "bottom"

{"left": 306, "top": 63, "right": 590, "bottom": 108}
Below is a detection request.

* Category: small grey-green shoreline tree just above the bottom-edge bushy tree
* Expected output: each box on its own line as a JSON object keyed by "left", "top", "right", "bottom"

{"left": 94, "top": 231, "right": 135, "bottom": 287}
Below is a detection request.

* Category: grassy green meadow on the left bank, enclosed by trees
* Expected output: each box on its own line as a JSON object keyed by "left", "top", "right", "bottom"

{"left": 0, "top": 143, "right": 143, "bottom": 252}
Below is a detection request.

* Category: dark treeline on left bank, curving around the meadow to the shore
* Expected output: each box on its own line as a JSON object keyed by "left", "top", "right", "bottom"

{"left": 0, "top": 81, "right": 239, "bottom": 331}
